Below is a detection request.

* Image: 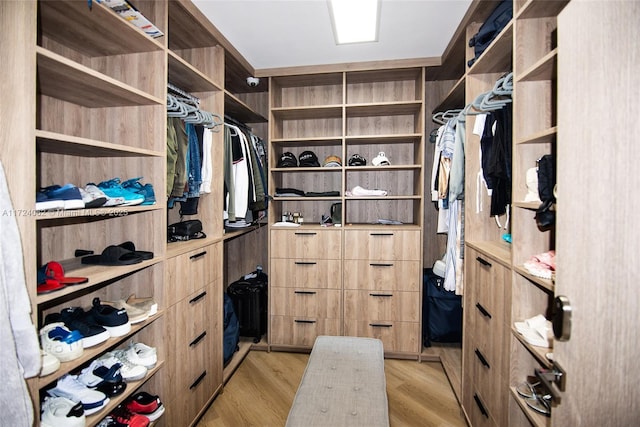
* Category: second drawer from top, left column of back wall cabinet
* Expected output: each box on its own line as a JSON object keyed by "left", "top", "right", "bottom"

{"left": 269, "top": 258, "right": 342, "bottom": 289}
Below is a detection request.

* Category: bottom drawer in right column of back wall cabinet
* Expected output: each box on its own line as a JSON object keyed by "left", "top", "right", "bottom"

{"left": 344, "top": 320, "right": 421, "bottom": 353}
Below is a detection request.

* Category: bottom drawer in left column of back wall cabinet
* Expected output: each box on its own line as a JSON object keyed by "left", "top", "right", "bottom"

{"left": 271, "top": 316, "right": 341, "bottom": 347}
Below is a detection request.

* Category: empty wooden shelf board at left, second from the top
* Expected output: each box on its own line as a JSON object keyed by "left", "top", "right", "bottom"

{"left": 36, "top": 47, "right": 164, "bottom": 108}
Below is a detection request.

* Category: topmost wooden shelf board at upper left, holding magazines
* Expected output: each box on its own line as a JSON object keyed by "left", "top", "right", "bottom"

{"left": 38, "top": 0, "right": 164, "bottom": 57}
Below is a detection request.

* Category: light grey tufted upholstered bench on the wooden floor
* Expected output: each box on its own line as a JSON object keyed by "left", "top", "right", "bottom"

{"left": 286, "top": 336, "right": 389, "bottom": 427}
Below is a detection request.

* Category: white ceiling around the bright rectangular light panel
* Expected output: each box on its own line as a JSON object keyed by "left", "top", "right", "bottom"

{"left": 193, "top": 0, "right": 471, "bottom": 70}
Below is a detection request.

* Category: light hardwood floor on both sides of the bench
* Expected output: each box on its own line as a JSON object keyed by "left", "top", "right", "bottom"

{"left": 197, "top": 351, "right": 467, "bottom": 427}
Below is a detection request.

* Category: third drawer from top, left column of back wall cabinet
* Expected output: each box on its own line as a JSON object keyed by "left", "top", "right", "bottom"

{"left": 269, "top": 287, "right": 342, "bottom": 319}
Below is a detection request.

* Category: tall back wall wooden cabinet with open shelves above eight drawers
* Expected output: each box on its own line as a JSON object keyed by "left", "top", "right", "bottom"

{"left": 269, "top": 68, "right": 424, "bottom": 356}
